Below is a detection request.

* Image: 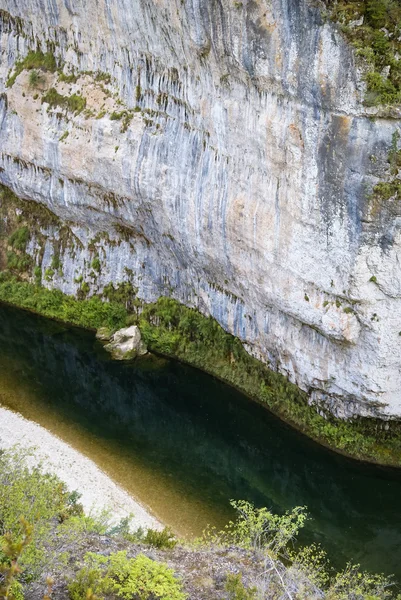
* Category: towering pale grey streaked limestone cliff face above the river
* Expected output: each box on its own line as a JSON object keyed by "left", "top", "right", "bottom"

{"left": 0, "top": 0, "right": 401, "bottom": 417}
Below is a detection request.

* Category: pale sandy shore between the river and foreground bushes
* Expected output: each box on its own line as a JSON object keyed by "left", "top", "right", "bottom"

{"left": 0, "top": 406, "right": 161, "bottom": 529}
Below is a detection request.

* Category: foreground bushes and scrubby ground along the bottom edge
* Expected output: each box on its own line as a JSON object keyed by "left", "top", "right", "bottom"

{"left": 0, "top": 447, "right": 400, "bottom": 600}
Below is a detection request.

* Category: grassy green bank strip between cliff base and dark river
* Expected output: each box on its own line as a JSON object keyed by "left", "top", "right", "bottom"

{"left": 0, "top": 272, "right": 401, "bottom": 467}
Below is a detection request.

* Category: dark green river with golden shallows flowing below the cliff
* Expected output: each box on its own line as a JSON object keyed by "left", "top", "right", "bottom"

{"left": 0, "top": 305, "right": 401, "bottom": 579}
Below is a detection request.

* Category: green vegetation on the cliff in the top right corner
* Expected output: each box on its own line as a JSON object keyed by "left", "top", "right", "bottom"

{"left": 325, "top": 0, "right": 401, "bottom": 105}
